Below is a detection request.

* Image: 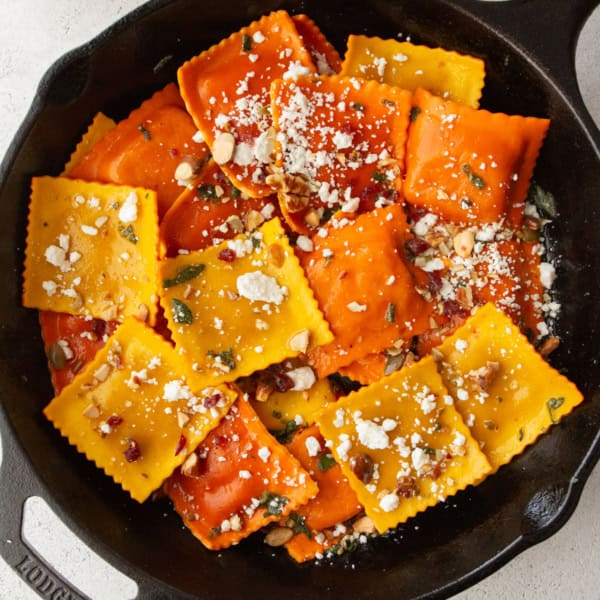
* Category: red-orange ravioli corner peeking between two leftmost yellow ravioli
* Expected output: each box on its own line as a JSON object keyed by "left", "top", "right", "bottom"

{"left": 40, "top": 310, "right": 118, "bottom": 394}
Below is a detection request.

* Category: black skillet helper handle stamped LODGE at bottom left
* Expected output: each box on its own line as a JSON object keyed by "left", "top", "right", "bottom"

{"left": 0, "top": 408, "right": 86, "bottom": 600}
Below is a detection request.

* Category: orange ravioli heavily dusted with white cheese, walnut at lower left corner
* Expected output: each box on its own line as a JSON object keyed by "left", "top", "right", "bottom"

{"left": 268, "top": 76, "right": 411, "bottom": 233}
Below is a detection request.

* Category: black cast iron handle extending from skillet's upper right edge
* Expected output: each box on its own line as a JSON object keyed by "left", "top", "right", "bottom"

{"left": 452, "top": 0, "right": 600, "bottom": 134}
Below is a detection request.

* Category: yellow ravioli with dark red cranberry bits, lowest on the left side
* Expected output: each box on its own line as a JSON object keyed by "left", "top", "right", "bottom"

{"left": 44, "top": 317, "right": 238, "bottom": 502}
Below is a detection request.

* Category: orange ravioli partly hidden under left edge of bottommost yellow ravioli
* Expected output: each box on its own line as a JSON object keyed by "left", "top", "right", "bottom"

{"left": 286, "top": 425, "right": 362, "bottom": 562}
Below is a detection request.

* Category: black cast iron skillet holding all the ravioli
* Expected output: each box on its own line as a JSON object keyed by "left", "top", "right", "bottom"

{"left": 0, "top": 0, "right": 600, "bottom": 600}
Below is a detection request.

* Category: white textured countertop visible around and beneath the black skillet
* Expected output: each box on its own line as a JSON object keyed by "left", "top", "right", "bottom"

{"left": 0, "top": 0, "right": 600, "bottom": 600}
